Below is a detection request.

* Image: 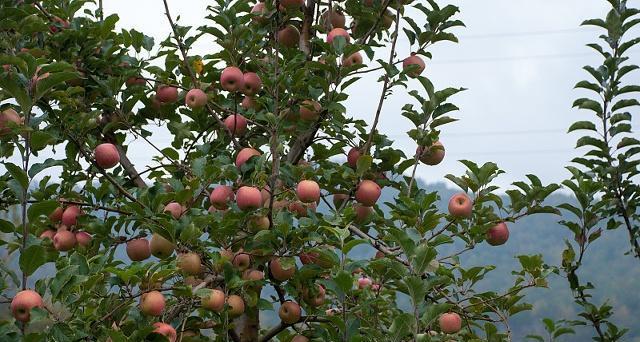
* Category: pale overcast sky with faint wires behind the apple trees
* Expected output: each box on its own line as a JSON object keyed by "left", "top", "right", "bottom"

{"left": 91, "top": 0, "right": 640, "bottom": 185}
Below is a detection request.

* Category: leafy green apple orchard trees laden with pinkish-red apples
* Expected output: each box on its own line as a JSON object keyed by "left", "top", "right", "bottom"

{"left": 0, "top": 0, "right": 640, "bottom": 342}
